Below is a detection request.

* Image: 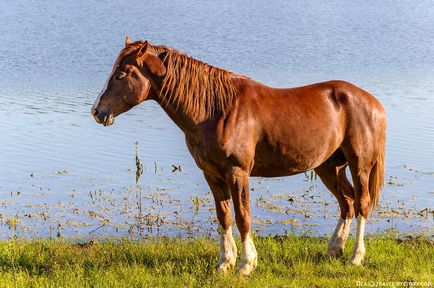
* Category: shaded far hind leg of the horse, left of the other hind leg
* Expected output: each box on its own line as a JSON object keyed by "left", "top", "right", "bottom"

{"left": 315, "top": 150, "right": 354, "bottom": 257}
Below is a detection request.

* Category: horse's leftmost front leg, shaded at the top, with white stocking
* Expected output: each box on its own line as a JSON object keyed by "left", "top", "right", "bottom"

{"left": 204, "top": 173, "right": 237, "bottom": 273}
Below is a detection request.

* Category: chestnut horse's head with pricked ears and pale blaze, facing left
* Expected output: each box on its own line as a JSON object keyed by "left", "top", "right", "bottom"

{"left": 92, "top": 36, "right": 166, "bottom": 126}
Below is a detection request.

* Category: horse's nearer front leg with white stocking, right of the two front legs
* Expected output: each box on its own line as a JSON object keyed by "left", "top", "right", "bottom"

{"left": 226, "top": 167, "right": 258, "bottom": 275}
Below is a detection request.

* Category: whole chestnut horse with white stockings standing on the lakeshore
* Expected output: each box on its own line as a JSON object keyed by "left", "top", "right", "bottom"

{"left": 92, "top": 37, "right": 386, "bottom": 275}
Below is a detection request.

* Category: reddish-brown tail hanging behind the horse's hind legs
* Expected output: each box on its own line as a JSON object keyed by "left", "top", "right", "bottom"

{"left": 369, "top": 120, "right": 386, "bottom": 209}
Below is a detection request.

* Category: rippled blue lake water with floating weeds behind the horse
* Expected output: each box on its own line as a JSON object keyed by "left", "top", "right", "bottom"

{"left": 0, "top": 1, "right": 434, "bottom": 238}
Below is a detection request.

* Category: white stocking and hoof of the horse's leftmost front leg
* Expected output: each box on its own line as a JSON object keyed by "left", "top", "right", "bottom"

{"left": 217, "top": 226, "right": 237, "bottom": 273}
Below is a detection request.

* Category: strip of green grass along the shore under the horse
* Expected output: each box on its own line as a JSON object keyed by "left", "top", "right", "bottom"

{"left": 0, "top": 236, "right": 434, "bottom": 287}
